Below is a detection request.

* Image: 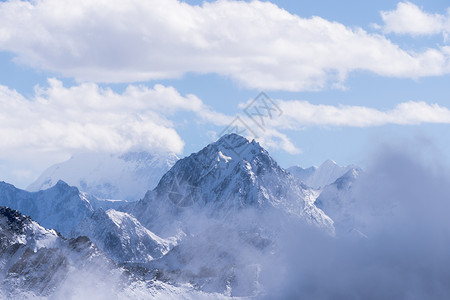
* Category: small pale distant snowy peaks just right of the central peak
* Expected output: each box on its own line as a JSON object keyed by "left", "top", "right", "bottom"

{"left": 287, "top": 159, "right": 357, "bottom": 189}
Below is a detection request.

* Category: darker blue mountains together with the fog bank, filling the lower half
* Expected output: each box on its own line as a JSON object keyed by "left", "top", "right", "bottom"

{"left": 0, "top": 134, "right": 450, "bottom": 299}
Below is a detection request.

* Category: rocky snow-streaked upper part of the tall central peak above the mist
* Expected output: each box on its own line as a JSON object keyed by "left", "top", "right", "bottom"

{"left": 150, "top": 133, "right": 282, "bottom": 210}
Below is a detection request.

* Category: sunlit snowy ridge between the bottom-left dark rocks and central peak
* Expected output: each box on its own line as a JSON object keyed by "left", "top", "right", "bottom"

{"left": 72, "top": 208, "right": 175, "bottom": 263}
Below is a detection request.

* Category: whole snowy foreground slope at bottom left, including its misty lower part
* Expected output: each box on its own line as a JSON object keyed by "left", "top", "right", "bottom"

{"left": 0, "top": 207, "right": 239, "bottom": 300}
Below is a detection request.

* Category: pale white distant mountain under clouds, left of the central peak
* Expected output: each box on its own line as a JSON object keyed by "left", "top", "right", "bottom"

{"left": 27, "top": 152, "right": 178, "bottom": 201}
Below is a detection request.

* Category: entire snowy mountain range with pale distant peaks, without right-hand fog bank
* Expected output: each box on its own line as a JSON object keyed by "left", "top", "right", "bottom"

{"left": 0, "top": 134, "right": 360, "bottom": 299}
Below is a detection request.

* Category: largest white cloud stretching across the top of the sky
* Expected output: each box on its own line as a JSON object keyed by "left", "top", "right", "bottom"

{"left": 0, "top": 0, "right": 450, "bottom": 91}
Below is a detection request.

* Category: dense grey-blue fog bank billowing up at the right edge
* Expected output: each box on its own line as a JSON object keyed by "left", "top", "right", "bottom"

{"left": 261, "top": 140, "right": 450, "bottom": 299}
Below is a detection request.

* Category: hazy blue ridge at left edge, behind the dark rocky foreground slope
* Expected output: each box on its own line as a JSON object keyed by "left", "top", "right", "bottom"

{"left": 0, "top": 181, "right": 125, "bottom": 236}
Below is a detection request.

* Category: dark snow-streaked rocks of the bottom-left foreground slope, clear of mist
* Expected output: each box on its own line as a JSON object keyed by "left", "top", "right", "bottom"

{"left": 0, "top": 207, "right": 118, "bottom": 299}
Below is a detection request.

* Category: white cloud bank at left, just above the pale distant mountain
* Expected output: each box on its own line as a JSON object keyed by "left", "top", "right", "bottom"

{"left": 0, "top": 79, "right": 192, "bottom": 156}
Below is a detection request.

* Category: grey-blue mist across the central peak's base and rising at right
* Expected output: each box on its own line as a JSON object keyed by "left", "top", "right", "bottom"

{"left": 0, "top": 140, "right": 450, "bottom": 300}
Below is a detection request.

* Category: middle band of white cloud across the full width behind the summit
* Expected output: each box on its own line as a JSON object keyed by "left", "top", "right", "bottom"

{"left": 0, "top": 79, "right": 450, "bottom": 164}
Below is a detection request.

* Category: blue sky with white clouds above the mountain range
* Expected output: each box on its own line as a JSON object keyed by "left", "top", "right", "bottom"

{"left": 0, "top": 0, "right": 450, "bottom": 187}
